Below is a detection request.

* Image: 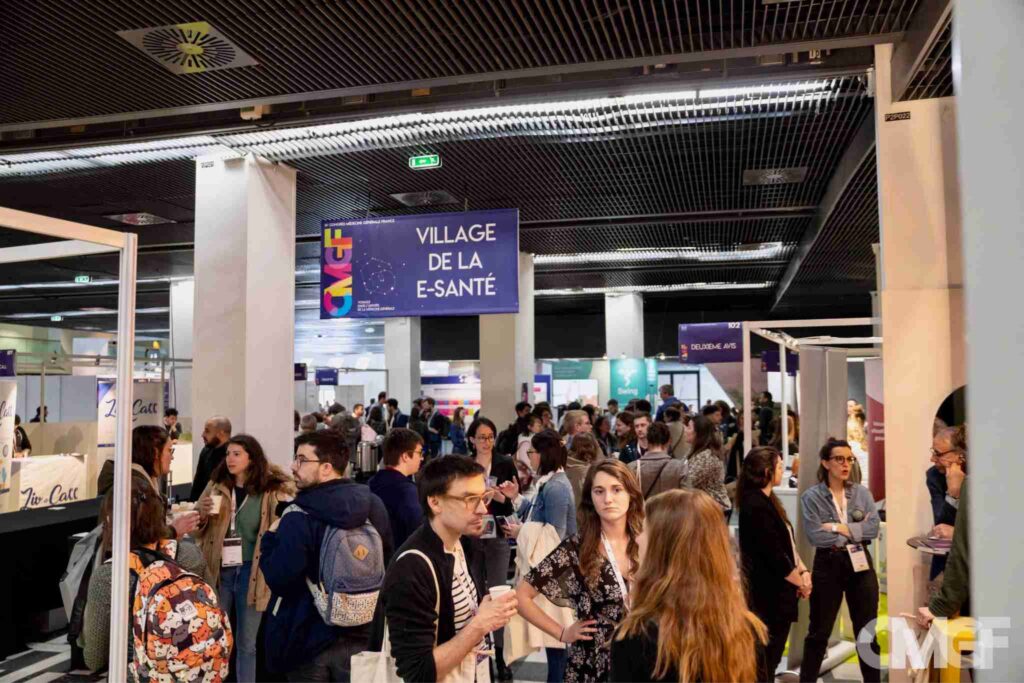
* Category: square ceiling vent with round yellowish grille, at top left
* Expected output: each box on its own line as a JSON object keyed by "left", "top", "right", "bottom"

{"left": 118, "top": 22, "right": 258, "bottom": 74}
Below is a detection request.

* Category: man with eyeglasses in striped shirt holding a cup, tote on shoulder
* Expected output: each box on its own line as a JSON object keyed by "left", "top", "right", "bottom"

{"left": 373, "top": 456, "right": 516, "bottom": 683}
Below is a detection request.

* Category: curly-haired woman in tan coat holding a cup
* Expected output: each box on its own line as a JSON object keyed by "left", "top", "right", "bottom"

{"left": 196, "top": 434, "right": 295, "bottom": 683}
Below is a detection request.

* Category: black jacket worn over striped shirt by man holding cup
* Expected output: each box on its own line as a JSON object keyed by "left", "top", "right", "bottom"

{"left": 370, "top": 520, "right": 486, "bottom": 681}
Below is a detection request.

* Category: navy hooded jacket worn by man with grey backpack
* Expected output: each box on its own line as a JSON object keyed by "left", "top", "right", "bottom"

{"left": 259, "top": 479, "right": 393, "bottom": 673}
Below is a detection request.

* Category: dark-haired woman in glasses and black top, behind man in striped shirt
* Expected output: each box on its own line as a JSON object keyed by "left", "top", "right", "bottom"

{"left": 466, "top": 418, "right": 519, "bottom": 681}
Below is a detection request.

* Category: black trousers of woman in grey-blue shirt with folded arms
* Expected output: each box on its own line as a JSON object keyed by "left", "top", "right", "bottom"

{"left": 800, "top": 548, "right": 882, "bottom": 683}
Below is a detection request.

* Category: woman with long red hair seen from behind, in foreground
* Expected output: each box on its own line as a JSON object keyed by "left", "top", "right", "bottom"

{"left": 610, "top": 489, "right": 767, "bottom": 683}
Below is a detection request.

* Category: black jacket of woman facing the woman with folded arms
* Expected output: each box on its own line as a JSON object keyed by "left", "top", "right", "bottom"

{"left": 739, "top": 490, "right": 799, "bottom": 624}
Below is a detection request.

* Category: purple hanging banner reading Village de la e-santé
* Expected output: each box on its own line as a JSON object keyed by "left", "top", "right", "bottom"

{"left": 321, "top": 209, "right": 519, "bottom": 319}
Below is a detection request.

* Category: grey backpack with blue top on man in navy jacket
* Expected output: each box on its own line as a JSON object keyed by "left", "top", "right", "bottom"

{"left": 284, "top": 505, "right": 384, "bottom": 627}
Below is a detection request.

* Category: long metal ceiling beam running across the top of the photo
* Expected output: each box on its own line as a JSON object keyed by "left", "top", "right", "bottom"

{"left": 0, "top": 32, "right": 903, "bottom": 133}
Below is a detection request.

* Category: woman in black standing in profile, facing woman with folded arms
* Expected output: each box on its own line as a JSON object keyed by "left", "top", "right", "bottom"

{"left": 736, "top": 446, "right": 811, "bottom": 681}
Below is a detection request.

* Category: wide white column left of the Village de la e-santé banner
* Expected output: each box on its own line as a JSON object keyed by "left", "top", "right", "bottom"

{"left": 191, "top": 156, "right": 296, "bottom": 466}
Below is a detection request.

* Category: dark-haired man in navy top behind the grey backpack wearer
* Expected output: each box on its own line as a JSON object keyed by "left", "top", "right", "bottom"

{"left": 368, "top": 427, "right": 424, "bottom": 548}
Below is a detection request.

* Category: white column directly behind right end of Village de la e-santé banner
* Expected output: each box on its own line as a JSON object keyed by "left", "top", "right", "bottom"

{"left": 480, "top": 254, "right": 537, "bottom": 429}
